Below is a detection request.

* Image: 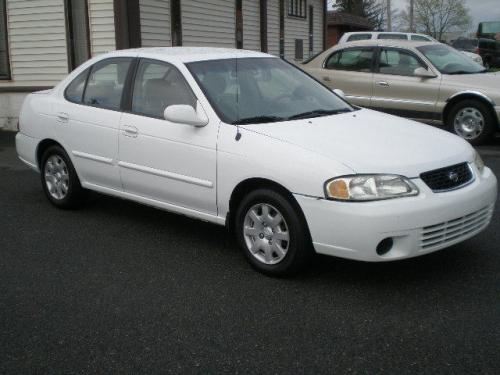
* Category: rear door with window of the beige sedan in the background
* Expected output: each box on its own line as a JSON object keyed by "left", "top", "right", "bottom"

{"left": 320, "top": 47, "right": 374, "bottom": 107}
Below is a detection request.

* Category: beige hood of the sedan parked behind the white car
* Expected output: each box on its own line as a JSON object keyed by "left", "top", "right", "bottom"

{"left": 443, "top": 72, "right": 500, "bottom": 94}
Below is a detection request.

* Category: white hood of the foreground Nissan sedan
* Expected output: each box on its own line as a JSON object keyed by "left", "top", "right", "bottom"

{"left": 242, "top": 109, "right": 473, "bottom": 178}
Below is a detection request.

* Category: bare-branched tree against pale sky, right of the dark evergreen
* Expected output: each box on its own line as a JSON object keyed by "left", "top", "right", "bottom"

{"left": 401, "top": 0, "right": 471, "bottom": 40}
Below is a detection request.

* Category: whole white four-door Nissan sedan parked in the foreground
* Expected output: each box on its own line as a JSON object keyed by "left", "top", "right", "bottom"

{"left": 16, "top": 48, "right": 497, "bottom": 275}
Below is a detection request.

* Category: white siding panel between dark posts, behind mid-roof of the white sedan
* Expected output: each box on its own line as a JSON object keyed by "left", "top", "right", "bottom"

{"left": 181, "top": 0, "right": 236, "bottom": 48}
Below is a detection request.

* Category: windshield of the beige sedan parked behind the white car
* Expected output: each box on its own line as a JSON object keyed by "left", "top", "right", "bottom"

{"left": 417, "top": 44, "right": 485, "bottom": 74}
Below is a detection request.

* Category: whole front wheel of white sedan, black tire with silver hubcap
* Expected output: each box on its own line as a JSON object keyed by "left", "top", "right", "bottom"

{"left": 234, "top": 189, "right": 313, "bottom": 276}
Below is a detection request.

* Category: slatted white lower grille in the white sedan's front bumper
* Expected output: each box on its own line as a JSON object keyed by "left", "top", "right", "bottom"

{"left": 420, "top": 205, "right": 494, "bottom": 250}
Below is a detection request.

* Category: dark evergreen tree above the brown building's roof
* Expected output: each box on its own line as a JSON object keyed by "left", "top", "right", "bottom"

{"left": 332, "top": 0, "right": 387, "bottom": 30}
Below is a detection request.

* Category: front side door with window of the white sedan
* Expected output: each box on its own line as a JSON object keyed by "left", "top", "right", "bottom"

{"left": 118, "top": 59, "right": 219, "bottom": 214}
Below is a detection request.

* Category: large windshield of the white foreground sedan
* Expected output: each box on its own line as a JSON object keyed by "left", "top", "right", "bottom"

{"left": 187, "top": 57, "right": 353, "bottom": 124}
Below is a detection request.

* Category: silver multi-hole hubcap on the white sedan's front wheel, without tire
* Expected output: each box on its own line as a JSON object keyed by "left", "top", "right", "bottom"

{"left": 243, "top": 203, "right": 290, "bottom": 264}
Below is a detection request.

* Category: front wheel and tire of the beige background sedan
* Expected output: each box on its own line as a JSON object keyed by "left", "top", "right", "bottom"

{"left": 447, "top": 99, "right": 496, "bottom": 146}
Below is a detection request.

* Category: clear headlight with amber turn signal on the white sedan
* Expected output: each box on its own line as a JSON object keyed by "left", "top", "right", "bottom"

{"left": 325, "top": 174, "right": 418, "bottom": 201}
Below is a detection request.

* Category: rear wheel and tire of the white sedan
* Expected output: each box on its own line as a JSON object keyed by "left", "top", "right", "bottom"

{"left": 40, "top": 145, "right": 87, "bottom": 209}
